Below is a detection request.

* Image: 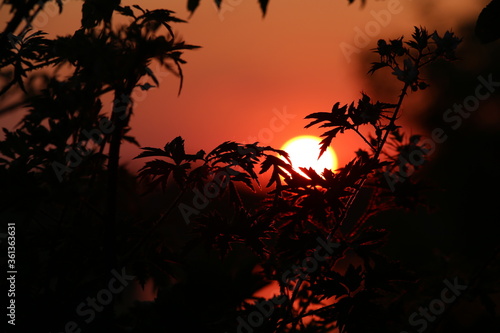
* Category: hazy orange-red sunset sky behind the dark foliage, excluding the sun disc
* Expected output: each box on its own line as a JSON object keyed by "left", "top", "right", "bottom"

{"left": 0, "top": 0, "right": 488, "bottom": 170}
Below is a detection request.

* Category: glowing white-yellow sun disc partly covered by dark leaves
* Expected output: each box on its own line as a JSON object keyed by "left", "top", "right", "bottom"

{"left": 281, "top": 135, "right": 338, "bottom": 176}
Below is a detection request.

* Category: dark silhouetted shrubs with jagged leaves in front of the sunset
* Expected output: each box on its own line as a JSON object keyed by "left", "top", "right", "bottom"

{"left": 0, "top": 1, "right": 500, "bottom": 333}
